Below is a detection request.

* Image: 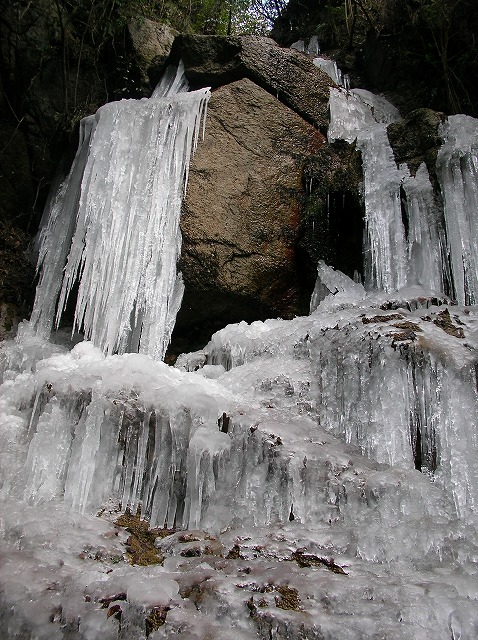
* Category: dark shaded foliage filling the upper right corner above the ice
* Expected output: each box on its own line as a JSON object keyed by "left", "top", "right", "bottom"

{"left": 272, "top": 0, "right": 478, "bottom": 116}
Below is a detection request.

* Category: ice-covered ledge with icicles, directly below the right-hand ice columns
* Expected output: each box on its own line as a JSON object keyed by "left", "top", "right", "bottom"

{"left": 193, "top": 288, "right": 478, "bottom": 517}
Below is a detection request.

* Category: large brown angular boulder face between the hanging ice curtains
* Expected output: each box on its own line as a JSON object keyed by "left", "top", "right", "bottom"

{"left": 177, "top": 79, "right": 325, "bottom": 352}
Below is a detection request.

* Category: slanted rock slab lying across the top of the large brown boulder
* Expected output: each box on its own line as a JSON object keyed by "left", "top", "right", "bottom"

{"left": 166, "top": 35, "right": 335, "bottom": 130}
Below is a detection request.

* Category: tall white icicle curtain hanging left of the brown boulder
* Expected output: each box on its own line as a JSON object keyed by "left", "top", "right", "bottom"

{"left": 31, "top": 70, "right": 209, "bottom": 359}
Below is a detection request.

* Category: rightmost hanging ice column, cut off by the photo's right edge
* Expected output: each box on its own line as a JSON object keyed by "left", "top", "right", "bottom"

{"left": 437, "top": 115, "right": 478, "bottom": 305}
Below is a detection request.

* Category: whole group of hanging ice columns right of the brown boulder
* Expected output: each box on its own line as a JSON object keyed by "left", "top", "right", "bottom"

{"left": 328, "top": 84, "right": 478, "bottom": 304}
